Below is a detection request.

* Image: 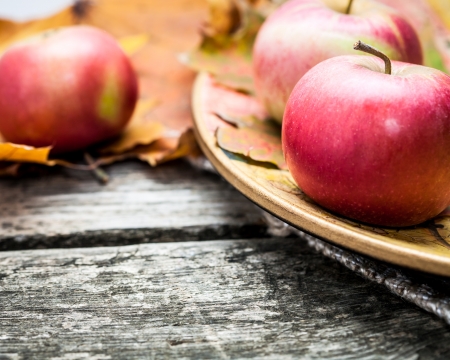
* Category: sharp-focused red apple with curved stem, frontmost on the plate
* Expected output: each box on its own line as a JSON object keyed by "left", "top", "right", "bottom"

{"left": 282, "top": 43, "right": 450, "bottom": 226}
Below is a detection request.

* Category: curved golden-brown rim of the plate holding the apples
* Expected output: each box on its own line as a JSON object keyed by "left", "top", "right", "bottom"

{"left": 191, "top": 72, "right": 450, "bottom": 277}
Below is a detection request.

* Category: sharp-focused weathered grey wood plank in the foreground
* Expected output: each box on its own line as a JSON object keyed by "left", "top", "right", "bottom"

{"left": 0, "top": 239, "right": 450, "bottom": 359}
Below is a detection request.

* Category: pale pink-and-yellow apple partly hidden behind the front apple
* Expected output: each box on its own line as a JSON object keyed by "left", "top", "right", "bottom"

{"left": 253, "top": 0, "right": 422, "bottom": 121}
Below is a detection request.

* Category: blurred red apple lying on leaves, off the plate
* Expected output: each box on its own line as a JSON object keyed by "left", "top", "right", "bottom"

{"left": 0, "top": 26, "right": 138, "bottom": 152}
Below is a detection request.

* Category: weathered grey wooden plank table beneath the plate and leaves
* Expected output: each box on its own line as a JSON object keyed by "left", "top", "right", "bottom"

{"left": 0, "top": 161, "right": 450, "bottom": 360}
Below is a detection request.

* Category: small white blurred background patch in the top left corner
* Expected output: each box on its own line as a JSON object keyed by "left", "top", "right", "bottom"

{"left": 0, "top": 0, "right": 73, "bottom": 21}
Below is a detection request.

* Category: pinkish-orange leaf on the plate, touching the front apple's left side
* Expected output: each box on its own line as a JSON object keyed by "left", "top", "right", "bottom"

{"left": 216, "top": 127, "right": 287, "bottom": 170}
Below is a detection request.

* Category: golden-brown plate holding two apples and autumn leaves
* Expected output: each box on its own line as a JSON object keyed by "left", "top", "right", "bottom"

{"left": 192, "top": 73, "right": 450, "bottom": 276}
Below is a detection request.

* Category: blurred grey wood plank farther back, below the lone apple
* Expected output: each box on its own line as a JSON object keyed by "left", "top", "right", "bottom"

{"left": 0, "top": 161, "right": 266, "bottom": 250}
